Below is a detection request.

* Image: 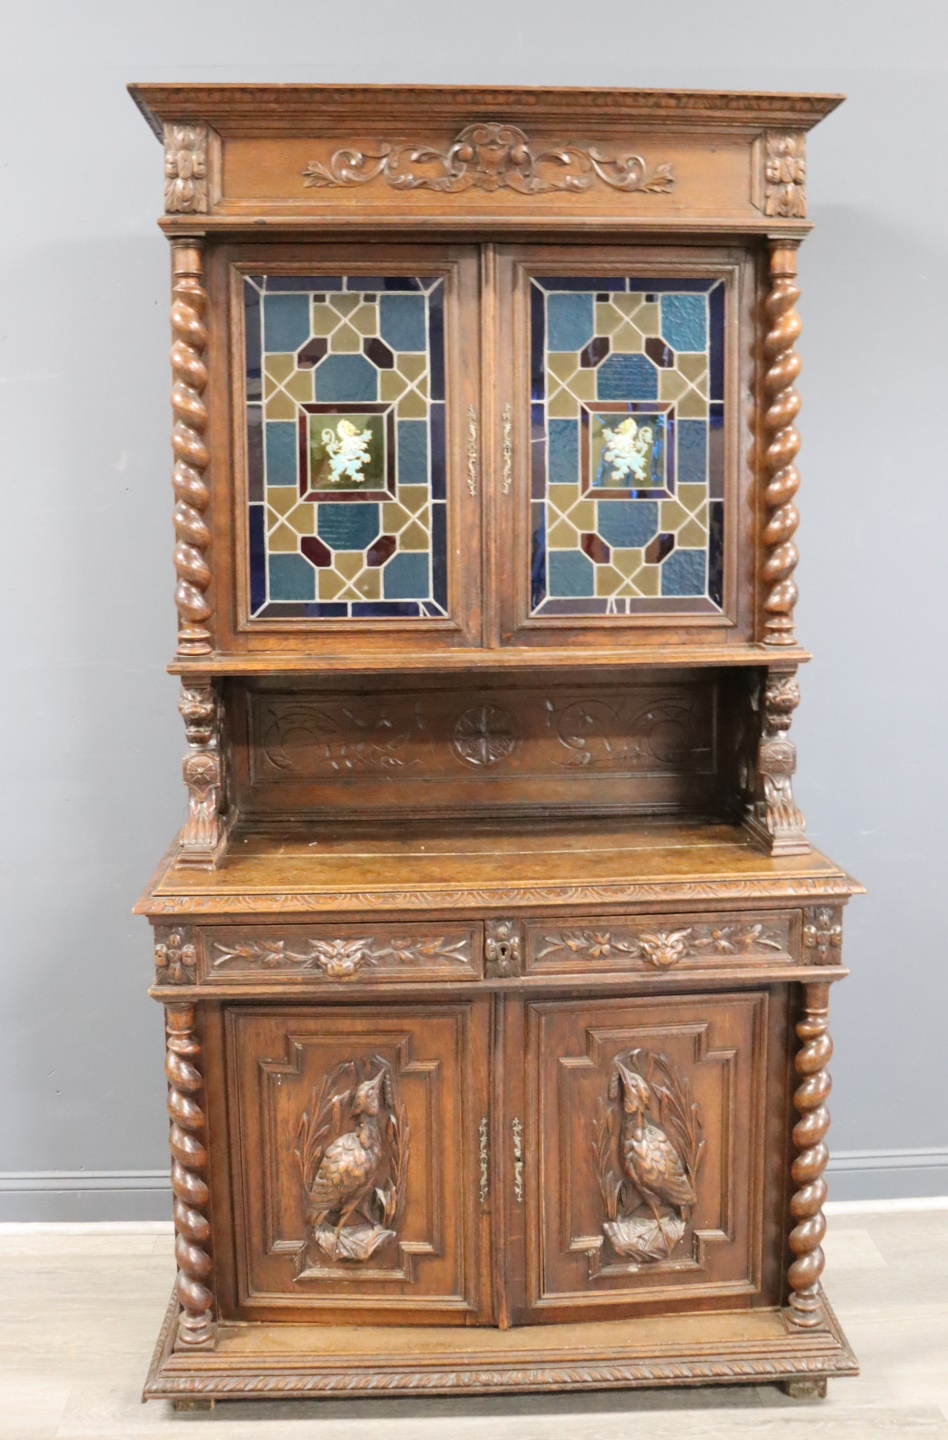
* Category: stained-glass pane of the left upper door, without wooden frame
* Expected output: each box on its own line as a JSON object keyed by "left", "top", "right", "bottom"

{"left": 243, "top": 275, "right": 448, "bottom": 619}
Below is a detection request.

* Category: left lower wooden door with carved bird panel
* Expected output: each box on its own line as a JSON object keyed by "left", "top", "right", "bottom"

{"left": 218, "top": 1001, "right": 491, "bottom": 1325}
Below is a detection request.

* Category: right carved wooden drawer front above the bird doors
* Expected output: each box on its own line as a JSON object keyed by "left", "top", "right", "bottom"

{"left": 523, "top": 910, "right": 800, "bottom": 976}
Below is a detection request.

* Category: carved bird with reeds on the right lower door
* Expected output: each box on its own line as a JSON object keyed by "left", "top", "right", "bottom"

{"left": 592, "top": 1050, "right": 705, "bottom": 1267}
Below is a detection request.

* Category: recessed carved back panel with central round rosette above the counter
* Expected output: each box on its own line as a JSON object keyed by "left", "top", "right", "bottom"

{"left": 231, "top": 672, "right": 733, "bottom": 816}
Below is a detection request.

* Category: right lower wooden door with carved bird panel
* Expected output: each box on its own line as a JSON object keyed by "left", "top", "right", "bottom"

{"left": 507, "top": 986, "right": 790, "bottom": 1323}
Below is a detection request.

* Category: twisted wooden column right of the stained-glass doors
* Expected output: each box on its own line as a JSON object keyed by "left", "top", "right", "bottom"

{"left": 762, "top": 240, "right": 802, "bottom": 645}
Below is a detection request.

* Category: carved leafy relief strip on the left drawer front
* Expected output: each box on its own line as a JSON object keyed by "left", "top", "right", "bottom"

{"left": 212, "top": 935, "right": 471, "bottom": 981}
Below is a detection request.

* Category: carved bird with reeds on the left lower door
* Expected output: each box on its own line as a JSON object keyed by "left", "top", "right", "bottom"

{"left": 294, "top": 1056, "right": 411, "bottom": 1280}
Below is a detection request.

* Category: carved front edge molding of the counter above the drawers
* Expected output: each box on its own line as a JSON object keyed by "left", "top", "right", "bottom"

{"left": 140, "top": 874, "right": 862, "bottom": 916}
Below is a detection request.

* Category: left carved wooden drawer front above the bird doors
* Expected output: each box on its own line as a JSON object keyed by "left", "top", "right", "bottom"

{"left": 197, "top": 922, "right": 483, "bottom": 988}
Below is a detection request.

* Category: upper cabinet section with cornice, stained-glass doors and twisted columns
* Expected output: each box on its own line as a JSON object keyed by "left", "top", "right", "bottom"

{"left": 133, "top": 85, "right": 839, "bottom": 672}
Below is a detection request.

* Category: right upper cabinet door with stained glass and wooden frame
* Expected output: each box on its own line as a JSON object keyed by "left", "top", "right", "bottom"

{"left": 494, "top": 246, "right": 755, "bottom": 648}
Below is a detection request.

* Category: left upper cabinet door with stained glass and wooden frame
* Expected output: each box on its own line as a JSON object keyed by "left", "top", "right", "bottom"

{"left": 212, "top": 245, "right": 480, "bottom": 654}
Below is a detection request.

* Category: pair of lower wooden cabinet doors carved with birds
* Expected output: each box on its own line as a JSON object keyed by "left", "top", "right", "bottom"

{"left": 210, "top": 985, "right": 792, "bottom": 1326}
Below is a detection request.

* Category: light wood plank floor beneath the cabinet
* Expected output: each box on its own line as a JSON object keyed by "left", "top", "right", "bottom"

{"left": 0, "top": 1210, "right": 948, "bottom": 1440}
